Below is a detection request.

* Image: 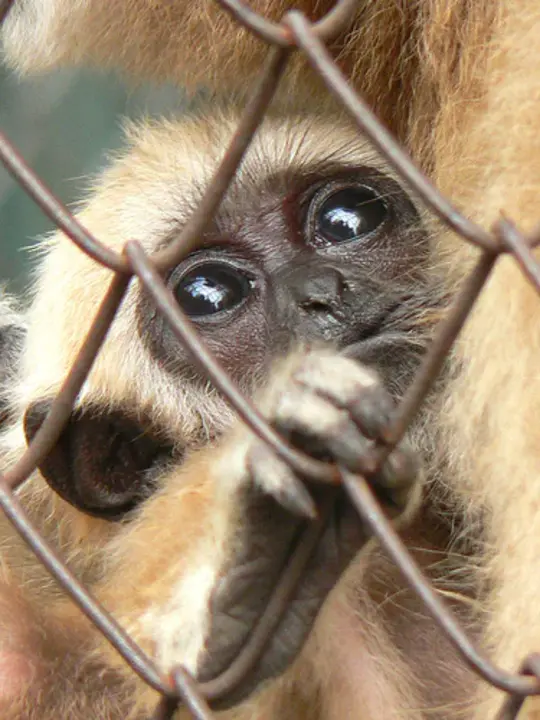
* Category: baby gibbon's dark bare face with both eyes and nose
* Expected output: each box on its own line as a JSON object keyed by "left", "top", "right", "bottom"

{"left": 139, "top": 166, "right": 427, "bottom": 391}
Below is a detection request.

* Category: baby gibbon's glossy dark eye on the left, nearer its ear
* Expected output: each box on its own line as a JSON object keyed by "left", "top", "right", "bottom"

{"left": 174, "top": 262, "right": 254, "bottom": 317}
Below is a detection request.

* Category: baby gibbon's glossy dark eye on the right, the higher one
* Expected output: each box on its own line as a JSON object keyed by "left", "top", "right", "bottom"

{"left": 314, "top": 187, "right": 388, "bottom": 243}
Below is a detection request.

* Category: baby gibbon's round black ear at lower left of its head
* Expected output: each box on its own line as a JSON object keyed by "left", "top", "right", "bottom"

{"left": 24, "top": 399, "right": 172, "bottom": 520}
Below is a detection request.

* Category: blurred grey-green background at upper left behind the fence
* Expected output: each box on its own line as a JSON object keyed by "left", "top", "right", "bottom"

{"left": 0, "top": 61, "right": 192, "bottom": 293}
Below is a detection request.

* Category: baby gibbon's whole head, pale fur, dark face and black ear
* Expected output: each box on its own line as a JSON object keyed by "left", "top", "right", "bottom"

{"left": 13, "top": 117, "right": 427, "bottom": 519}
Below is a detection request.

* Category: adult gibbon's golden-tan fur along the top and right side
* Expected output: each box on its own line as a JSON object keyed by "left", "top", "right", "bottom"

{"left": 1, "top": 0, "right": 540, "bottom": 718}
